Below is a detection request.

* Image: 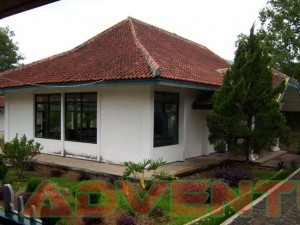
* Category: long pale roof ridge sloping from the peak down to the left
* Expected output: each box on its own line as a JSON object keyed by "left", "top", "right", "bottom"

{"left": 0, "top": 20, "right": 126, "bottom": 77}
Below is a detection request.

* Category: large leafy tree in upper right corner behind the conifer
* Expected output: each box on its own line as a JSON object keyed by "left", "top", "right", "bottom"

{"left": 259, "top": 0, "right": 300, "bottom": 79}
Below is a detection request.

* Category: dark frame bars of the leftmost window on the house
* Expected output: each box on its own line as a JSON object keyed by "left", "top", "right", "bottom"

{"left": 34, "top": 93, "right": 62, "bottom": 140}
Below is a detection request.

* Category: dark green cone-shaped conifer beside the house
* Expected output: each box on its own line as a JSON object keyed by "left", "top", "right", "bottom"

{"left": 207, "top": 26, "right": 290, "bottom": 160}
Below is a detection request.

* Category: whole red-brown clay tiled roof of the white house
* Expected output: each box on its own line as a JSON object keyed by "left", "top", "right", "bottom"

{"left": 0, "top": 17, "right": 230, "bottom": 89}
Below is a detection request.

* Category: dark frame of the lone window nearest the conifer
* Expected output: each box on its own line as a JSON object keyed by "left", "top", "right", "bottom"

{"left": 153, "top": 91, "right": 179, "bottom": 148}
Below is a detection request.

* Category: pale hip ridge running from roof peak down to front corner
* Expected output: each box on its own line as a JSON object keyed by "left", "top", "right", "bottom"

{"left": 127, "top": 17, "right": 162, "bottom": 77}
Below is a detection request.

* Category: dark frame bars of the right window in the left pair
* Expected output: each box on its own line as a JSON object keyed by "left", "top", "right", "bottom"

{"left": 64, "top": 92, "right": 98, "bottom": 144}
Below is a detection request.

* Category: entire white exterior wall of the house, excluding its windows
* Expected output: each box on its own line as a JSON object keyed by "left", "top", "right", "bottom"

{"left": 5, "top": 86, "right": 213, "bottom": 164}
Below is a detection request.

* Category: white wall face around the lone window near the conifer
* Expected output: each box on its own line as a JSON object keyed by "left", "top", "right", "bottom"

{"left": 151, "top": 87, "right": 211, "bottom": 162}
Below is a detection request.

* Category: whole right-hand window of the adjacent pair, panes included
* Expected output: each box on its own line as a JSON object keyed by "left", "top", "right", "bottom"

{"left": 66, "top": 93, "right": 97, "bottom": 143}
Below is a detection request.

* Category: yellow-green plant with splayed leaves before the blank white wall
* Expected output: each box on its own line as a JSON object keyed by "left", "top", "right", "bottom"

{"left": 123, "top": 159, "right": 166, "bottom": 189}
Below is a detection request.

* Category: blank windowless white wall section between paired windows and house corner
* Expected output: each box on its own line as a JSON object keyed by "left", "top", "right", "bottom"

{"left": 100, "top": 86, "right": 153, "bottom": 163}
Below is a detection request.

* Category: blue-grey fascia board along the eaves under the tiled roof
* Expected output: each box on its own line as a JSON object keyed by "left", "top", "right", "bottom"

{"left": 0, "top": 78, "right": 219, "bottom": 96}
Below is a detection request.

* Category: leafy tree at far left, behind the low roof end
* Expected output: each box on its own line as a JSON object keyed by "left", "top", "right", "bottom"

{"left": 0, "top": 27, "right": 24, "bottom": 72}
